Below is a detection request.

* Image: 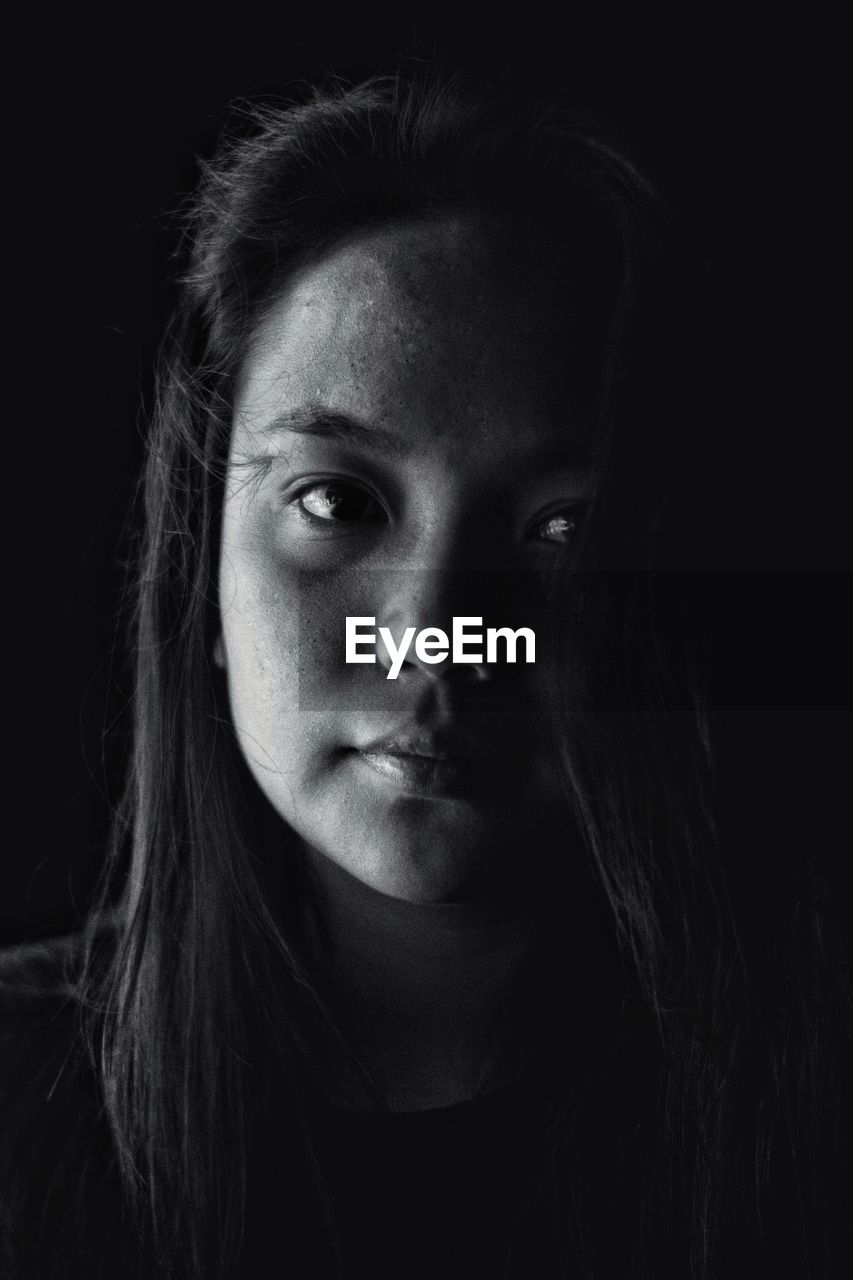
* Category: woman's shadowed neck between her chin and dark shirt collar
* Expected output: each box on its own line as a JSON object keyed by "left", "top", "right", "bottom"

{"left": 295, "top": 851, "right": 539, "bottom": 1111}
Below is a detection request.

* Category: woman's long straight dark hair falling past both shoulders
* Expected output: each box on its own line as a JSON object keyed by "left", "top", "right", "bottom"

{"left": 76, "top": 70, "right": 833, "bottom": 1280}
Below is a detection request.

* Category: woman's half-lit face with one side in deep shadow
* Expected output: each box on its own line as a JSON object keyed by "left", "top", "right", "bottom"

{"left": 216, "top": 216, "right": 593, "bottom": 901}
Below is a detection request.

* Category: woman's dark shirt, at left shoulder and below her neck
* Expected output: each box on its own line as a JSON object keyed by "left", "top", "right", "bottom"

{"left": 0, "top": 938, "right": 567, "bottom": 1280}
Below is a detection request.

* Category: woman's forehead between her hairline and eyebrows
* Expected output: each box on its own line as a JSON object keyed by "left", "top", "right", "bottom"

{"left": 234, "top": 216, "right": 591, "bottom": 460}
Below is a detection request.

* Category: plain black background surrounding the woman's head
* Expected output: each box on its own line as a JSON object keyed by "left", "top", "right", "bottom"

{"left": 0, "top": 9, "right": 850, "bottom": 940}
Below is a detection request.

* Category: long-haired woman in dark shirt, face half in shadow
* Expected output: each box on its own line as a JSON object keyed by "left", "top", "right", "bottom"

{"left": 6, "top": 64, "right": 843, "bottom": 1277}
